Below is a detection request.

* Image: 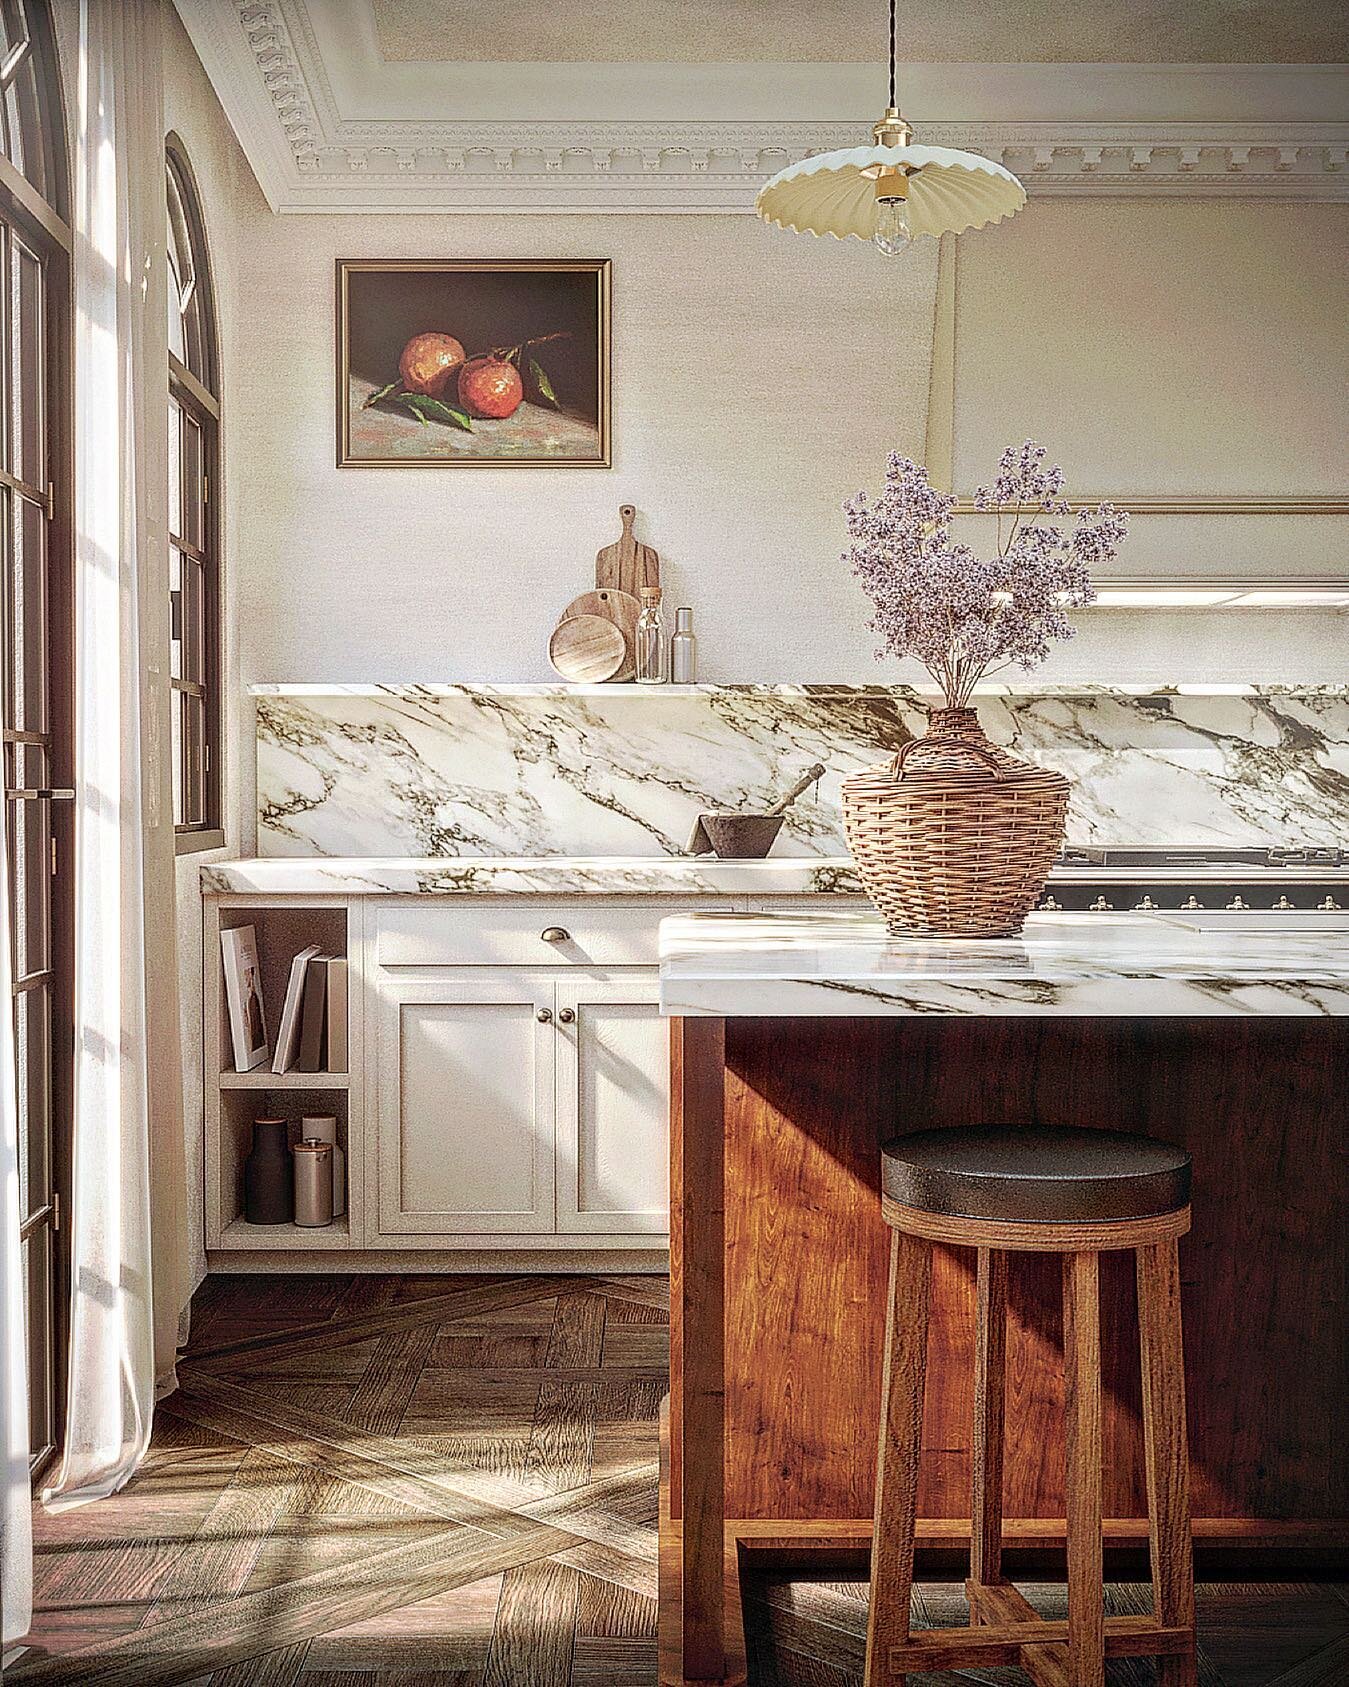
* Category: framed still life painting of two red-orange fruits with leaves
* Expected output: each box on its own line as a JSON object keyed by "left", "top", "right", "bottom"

{"left": 337, "top": 258, "right": 610, "bottom": 469}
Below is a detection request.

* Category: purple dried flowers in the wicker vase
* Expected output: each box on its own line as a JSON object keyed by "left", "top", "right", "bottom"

{"left": 843, "top": 440, "right": 1128, "bottom": 707}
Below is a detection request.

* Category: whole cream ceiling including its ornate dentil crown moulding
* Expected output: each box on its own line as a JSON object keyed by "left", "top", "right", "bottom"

{"left": 174, "top": 0, "right": 1349, "bottom": 216}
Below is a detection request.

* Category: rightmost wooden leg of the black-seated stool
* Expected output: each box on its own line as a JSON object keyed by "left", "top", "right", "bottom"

{"left": 1138, "top": 1238, "right": 1199, "bottom": 1687}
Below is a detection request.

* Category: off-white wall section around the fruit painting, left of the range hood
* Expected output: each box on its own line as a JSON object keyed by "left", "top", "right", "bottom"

{"left": 234, "top": 216, "right": 936, "bottom": 680}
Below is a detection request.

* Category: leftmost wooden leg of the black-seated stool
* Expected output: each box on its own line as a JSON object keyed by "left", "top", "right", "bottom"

{"left": 867, "top": 1230, "right": 932, "bottom": 1687}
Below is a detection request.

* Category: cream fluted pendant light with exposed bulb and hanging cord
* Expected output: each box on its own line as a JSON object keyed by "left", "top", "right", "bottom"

{"left": 754, "top": 0, "right": 1025, "bottom": 258}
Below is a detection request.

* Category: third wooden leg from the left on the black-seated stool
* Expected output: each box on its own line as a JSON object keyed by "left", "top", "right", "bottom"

{"left": 1064, "top": 1253, "right": 1106, "bottom": 1687}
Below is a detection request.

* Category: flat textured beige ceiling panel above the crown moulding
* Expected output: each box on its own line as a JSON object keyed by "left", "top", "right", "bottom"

{"left": 369, "top": 0, "right": 1349, "bottom": 64}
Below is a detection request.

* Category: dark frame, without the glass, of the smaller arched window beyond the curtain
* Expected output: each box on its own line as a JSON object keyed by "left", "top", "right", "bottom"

{"left": 164, "top": 133, "right": 224, "bottom": 855}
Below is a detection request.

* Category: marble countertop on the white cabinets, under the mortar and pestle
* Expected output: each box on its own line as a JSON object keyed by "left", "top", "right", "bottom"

{"left": 201, "top": 855, "right": 862, "bottom": 897}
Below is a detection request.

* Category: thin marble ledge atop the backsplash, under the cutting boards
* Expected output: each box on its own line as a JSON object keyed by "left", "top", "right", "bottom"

{"left": 248, "top": 680, "right": 1349, "bottom": 702}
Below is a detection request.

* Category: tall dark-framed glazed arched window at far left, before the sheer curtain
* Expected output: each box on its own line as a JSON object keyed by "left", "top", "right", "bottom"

{"left": 0, "top": 0, "right": 74, "bottom": 1468}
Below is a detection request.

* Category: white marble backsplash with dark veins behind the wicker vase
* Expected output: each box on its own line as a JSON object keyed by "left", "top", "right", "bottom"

{"left": 255, "top": 685, "right": 1349, "bottom": 857}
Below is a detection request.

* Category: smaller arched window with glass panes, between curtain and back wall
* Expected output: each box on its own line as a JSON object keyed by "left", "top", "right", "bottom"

{"left": 167, "top": 135, "right": 224, "bottom": 852}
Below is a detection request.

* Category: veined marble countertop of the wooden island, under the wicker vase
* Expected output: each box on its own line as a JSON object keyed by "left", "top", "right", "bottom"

{"left": 661, "top": 911, "right": 1349, "bottom": 1019}
